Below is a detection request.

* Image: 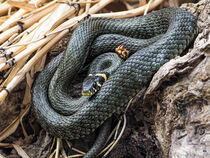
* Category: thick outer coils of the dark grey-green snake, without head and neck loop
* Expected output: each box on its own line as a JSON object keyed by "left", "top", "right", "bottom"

{"left": 32, "top": 8, "right": 197, "bottom": 143}
